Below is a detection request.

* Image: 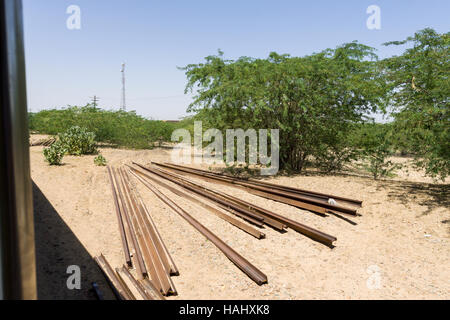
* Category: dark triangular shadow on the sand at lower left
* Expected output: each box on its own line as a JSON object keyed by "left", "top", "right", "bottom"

{"left": 33, "top": 182, "right": 113, "bottom": 300}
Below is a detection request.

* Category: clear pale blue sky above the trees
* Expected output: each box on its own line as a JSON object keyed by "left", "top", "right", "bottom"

{"left": 23, "top": 0, "right": 450, "bottom": 119}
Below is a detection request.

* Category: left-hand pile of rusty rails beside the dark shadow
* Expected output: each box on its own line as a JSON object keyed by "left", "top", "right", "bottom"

{"left": 96, "top": 167, "right": 179, "bottom": 299}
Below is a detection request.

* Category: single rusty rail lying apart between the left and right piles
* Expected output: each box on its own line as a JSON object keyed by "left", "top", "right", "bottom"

{"left": 132, "top": 169, "right": 267, "bottom": 285}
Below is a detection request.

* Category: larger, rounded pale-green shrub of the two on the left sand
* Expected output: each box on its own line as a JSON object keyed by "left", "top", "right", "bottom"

{"left": 58, "top": 126, "right": 97, "bottom": 156}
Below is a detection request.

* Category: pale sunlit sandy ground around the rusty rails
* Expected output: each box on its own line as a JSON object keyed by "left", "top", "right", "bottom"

{"left": 30, "top": 136, "right": 450, "bottom": 299}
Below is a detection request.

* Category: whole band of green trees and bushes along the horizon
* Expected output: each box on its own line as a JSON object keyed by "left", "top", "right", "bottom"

{"left": 29, "top": 29, "right": 450, "bottom": 179}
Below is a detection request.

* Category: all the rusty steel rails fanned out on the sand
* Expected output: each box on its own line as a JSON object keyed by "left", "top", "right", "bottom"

{"left": 96, "top": 162, "right": 362, "bottom": 299}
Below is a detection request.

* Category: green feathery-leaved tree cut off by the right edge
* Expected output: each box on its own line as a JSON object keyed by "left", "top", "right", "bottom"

{"left": 383, "top": 29, "right": 450, "bottom": 179}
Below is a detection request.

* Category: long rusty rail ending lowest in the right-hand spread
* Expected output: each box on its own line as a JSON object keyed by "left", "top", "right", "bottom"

{"left": 133, "top": 162, "right": 337, "bottom": 248}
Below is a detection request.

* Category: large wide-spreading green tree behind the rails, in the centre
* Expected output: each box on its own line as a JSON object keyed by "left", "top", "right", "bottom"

{"left": 183, "top": 42, "right": 386, "bottom": 170}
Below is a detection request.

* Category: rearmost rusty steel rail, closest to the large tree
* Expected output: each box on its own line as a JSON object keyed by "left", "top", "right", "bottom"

{"left": 153, "top": 162, "right": 362, "bottom": 207}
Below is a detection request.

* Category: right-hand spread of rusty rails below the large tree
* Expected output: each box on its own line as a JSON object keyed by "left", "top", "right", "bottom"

{"left": 133, "top": 162, "right": 361, "bottom": 247}
